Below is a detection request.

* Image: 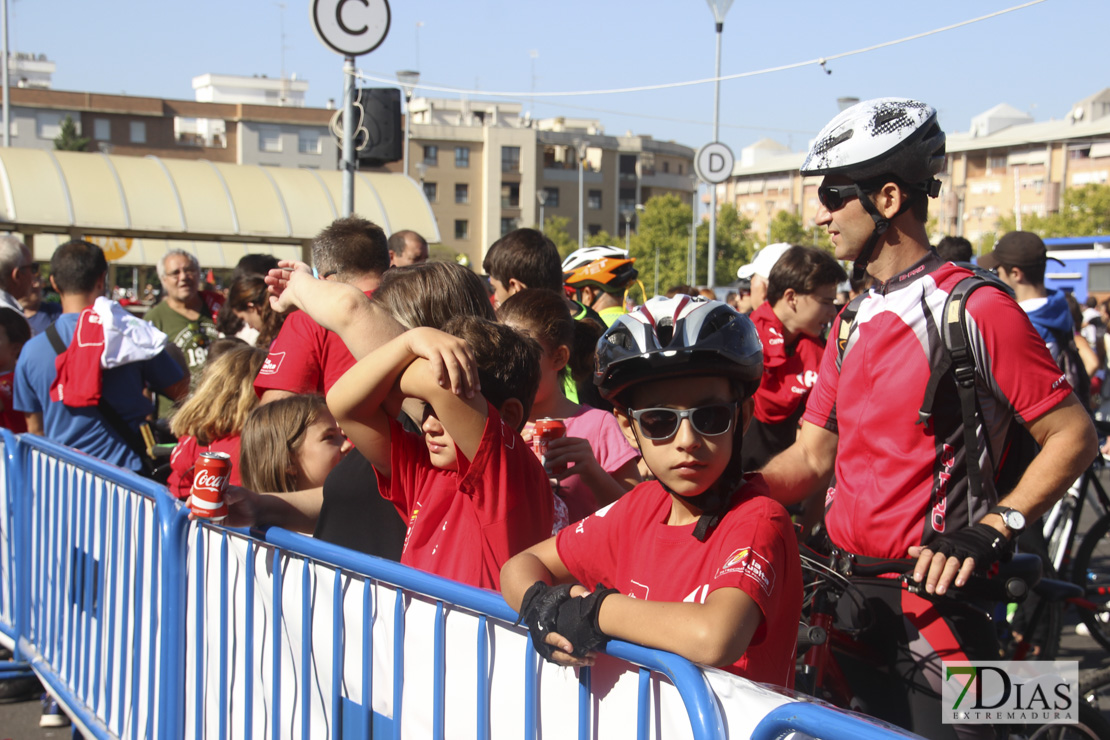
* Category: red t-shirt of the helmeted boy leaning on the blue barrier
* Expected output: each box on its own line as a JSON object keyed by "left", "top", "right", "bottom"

{"left": 555, "top": 474, "right": 801, "bottom": 688}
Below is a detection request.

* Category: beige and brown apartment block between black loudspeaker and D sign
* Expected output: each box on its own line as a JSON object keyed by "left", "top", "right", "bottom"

{"left": 399, "top": 98, "right": 695, "bottom": 264}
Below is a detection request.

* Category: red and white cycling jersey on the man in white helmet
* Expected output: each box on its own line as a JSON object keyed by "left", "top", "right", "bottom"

{"left": 803, "top": 253, "right": 1071, "bottom": 558}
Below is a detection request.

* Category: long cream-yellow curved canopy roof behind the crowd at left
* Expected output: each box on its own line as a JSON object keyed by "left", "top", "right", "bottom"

{"left": 0, "top": 149, "right": 441, "bottom": 262}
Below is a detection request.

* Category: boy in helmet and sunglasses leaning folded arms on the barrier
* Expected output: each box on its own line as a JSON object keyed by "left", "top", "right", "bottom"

{"left": 501, "top": 295, "right": 801, "bottom": 687}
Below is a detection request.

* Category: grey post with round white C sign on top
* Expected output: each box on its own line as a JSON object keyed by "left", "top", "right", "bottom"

{"left": 311, "top": 0, "right": 390, "bottom": 216}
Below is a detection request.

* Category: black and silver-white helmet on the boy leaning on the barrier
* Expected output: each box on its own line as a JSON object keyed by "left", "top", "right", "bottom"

{"left": 594, "top": 295, "right": 763, "bottom": 408}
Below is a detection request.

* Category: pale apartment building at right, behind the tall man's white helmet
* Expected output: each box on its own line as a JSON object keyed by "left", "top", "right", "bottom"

{"left": 718, "top": 88, "right": 1110, "bottom": 247}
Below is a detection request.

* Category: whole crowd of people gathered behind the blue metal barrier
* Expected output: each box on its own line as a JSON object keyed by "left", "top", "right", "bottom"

{"left": 0, "top": 99, "right": 1110, "bottom": 737}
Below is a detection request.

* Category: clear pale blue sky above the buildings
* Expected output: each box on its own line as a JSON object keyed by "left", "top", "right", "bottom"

{"left": 9, "top": 0, "right": 1110, "bottom": 154}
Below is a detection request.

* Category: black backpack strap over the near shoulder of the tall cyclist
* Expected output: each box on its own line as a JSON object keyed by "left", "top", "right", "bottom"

{"left": 917, "top": 275, "right": 997, "bottom": 524}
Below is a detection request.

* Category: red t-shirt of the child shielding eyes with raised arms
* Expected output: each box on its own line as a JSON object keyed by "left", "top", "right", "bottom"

{"left": 377, "top": 404, "right": 554, "bottom": 590}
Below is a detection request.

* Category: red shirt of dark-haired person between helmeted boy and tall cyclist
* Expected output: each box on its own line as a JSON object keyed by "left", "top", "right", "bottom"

{"left": 751, "top": 303, "right": 825, "bottom": 424}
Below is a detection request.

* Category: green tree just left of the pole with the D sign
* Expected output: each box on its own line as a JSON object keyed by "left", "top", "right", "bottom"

{"left": 630, "top": 198, "right": 694, "bottom": 296}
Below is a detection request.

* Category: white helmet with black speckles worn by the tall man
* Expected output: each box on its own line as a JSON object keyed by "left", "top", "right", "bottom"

{"left": 801, "top": 98, "right": 945, "bottom": 190}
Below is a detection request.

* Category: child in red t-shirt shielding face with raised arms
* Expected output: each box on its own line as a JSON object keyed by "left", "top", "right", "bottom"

{"left": 327, "top": 316, "right": 554, "bottom": 588}
